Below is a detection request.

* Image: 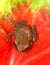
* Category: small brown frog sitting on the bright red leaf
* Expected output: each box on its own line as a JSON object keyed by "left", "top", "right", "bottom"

{"left": 2, "top": 15, "right": 38, "bottom": 52}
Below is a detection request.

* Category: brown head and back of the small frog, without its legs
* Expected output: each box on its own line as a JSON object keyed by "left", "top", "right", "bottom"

{"left": 15, "top": 25, "right": 33, "bottom": 51}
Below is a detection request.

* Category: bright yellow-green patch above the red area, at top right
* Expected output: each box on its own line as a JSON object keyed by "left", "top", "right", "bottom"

{"left": 30, "top": 0, "right": 50, "bottom": 10}
